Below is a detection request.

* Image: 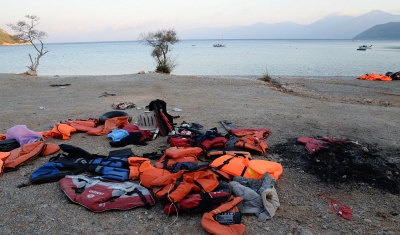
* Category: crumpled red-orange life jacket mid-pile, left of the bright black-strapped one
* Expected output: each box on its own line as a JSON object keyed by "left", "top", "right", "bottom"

{"left": 154, "top": 147, "right": 203, "bottom": 169}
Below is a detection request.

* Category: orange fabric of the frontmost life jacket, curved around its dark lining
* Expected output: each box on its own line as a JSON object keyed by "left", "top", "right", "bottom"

{"left": 201, "top": 197, "right": 246, "bottom": 235}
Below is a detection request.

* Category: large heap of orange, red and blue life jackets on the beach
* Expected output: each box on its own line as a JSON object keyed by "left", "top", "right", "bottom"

{"left": 0, "top": 105, "right": 283, "bottom": 234}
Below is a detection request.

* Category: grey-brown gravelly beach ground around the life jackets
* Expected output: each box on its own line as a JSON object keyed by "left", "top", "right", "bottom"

{"left": 0, "top": 73, "right": 400, "bottom": 234}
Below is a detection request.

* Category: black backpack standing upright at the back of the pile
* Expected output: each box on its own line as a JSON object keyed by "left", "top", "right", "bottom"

{"left": 149, "top": 99, "right": 175, "bottom": 136}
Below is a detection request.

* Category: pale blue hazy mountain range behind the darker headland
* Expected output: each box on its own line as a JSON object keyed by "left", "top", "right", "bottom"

{"left": 178, "top": 10, "right": 400, "bottom": 39}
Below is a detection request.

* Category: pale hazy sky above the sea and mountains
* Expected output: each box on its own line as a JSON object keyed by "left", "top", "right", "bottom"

{"left": 0, "top": 0, "right": 400, "bottom": 42}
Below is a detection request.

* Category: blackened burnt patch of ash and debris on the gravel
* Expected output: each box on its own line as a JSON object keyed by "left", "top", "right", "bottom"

{"left": 268, "top": 137, "right": 400, "bottom": 194}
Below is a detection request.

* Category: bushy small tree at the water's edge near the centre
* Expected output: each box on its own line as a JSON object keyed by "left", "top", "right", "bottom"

{"left": 139, "top": 29, "right": 179, "bottom": 73}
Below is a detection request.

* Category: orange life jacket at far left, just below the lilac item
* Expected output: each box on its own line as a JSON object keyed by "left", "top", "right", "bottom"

{"left": 4, "top": 141, "right": 60, "bottom": 170}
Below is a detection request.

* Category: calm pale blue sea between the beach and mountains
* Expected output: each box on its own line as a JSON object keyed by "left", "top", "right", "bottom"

{"left": 0, "top": 40, "right": 400, "bottom": 76}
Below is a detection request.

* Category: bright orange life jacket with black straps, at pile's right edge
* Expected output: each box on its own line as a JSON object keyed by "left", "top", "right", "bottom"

{"left": 210, "top": 155, "right": 283, "bottom": 180}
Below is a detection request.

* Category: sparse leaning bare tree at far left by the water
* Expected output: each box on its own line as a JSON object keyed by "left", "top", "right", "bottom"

{"left": 7, "top": 15, "right": 49, "bottom": 76}
